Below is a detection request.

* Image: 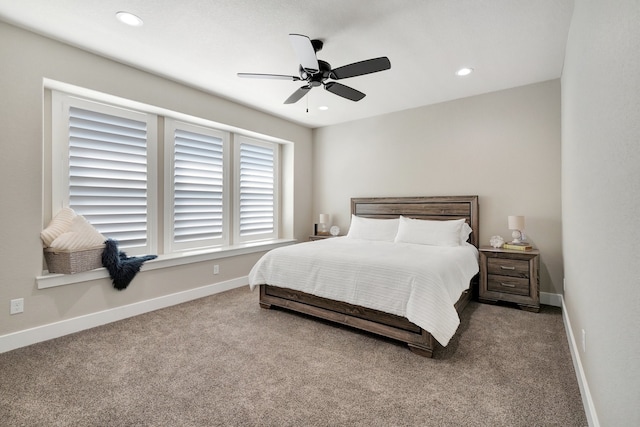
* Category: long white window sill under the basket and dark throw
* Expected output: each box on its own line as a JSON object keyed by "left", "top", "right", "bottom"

{"left": 36, "top": 239, "right": 296, "bottom": 289}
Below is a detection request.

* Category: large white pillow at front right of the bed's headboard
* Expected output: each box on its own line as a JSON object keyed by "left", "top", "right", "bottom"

{"left": 395, "top": 216, "right": 464, "bottom": 246}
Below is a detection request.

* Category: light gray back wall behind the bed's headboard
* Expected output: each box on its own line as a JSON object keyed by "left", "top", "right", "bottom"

{"left": 313, "top": 80, "right": 563, "bottom": 294}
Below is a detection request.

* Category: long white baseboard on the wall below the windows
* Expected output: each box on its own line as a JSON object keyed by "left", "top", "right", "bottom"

{"left": 0, "top": 276, "right": 249, "bottom": 353}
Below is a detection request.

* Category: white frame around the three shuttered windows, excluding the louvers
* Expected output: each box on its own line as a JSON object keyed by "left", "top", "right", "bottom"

{"left": 43, "top": 87, "right": 288, "bottom": 262}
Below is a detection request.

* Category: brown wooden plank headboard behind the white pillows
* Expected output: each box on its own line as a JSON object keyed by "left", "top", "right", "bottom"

{"left": 351, "top": 196, "right": 480, "bottom": 247}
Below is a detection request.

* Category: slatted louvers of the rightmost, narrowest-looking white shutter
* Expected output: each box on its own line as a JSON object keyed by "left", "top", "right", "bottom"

{"left": 236, "top": 138, "right": 278, "bottom": 242}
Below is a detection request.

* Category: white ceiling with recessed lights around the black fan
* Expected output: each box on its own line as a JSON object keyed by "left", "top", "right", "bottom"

{"left": 0, "top": 0, "right": 573, "bottom": 127}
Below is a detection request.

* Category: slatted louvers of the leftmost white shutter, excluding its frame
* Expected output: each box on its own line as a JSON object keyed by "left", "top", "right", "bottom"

{"left": 69, "top": 107, "right": 147, "bottom": 247}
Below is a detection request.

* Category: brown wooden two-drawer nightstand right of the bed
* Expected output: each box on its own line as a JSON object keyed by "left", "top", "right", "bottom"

{"left": 478, "top": 246, "right": 540, "bottom": 313}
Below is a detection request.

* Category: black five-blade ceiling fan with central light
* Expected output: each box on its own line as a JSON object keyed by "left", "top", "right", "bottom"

{"left": 238, "top": 34, "right": 391, "bottom": 104}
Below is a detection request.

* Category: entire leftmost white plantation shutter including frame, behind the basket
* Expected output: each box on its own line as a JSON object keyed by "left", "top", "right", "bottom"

{"left": 53, "top": 94, "right": 155, "bottom": 254}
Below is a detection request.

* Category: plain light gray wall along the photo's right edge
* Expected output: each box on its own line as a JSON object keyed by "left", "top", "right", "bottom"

{"left": 562, "top": 0, "right": 640, "bottom": 426}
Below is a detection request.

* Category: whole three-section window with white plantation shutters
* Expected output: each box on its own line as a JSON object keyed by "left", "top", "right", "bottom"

{"left": 51, "top": 90, "right": 280, "bottom": 255}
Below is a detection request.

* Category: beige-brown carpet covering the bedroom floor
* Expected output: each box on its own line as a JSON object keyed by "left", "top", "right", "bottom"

{"left": 0, "top": 287, "right": 587, "bottom": 426}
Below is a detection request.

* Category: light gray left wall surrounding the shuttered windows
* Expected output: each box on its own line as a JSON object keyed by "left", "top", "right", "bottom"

{"left": 0, "top": 22, "right": 312, "bottom": 336}
